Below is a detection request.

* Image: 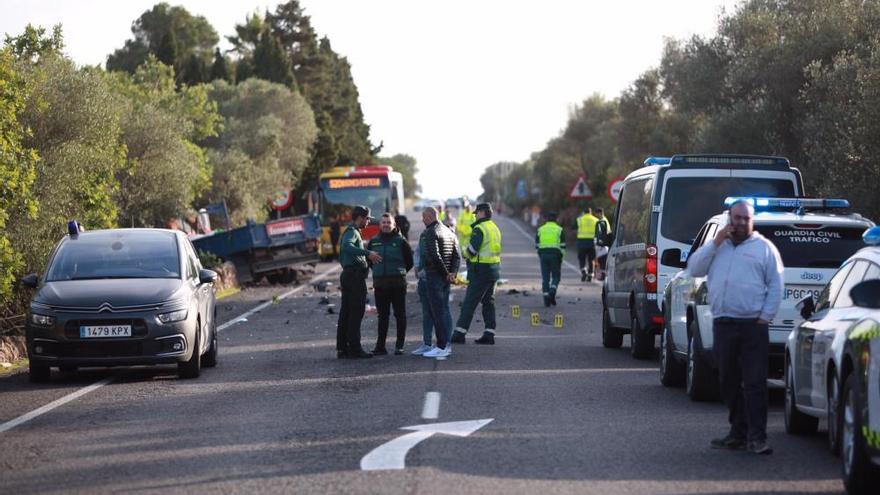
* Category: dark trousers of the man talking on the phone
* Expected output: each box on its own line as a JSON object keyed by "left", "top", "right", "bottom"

{"left": 712, "top": 318, "right": 770, "bottom": 441}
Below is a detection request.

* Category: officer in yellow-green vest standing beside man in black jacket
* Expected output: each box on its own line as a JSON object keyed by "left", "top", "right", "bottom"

{"left": 452, "top": 203, "right": 501, "bottom": 345}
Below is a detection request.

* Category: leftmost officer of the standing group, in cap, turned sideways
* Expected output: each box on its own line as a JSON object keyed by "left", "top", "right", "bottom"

{"left": 336, "top": 206, "right": 382, "bottom": 359}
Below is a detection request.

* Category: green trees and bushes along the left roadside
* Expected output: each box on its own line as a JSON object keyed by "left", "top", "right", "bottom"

{"left": 0, "top": 0, "right": 417, "bottom": 319}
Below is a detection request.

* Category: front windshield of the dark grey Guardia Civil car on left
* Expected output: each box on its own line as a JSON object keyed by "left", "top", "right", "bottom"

{"left": 46, "top": 230, "right": 180, "bottom": 282}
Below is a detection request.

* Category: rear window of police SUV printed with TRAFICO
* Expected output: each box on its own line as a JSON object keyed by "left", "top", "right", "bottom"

{"left": 755, "top": 223, "right": 865, "bottom": 269}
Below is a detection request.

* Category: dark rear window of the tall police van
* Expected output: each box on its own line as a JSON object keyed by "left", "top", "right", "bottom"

{"left": 660, "top": 177, "right": 795, "bottom": 244}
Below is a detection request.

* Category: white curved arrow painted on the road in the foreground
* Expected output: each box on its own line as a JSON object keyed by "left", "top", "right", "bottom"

{"left": 361, "top": 418, "right": 494, "bottom": 471}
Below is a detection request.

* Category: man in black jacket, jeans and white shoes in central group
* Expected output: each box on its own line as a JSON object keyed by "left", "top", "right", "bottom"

{"left": 419, "top": 207, "right": 461, "bottom": 359}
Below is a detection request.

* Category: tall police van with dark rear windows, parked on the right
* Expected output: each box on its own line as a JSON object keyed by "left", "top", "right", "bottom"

{"left": 602, "top": 154, "right": 804, "bottom": 359}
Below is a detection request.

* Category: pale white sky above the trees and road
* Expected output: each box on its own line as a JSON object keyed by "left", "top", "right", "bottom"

{"left": 0, "top": 0, "right": 739, "bottom": 202}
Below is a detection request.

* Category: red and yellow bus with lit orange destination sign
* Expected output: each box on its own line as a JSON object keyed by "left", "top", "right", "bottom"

{"left": 317, "top": 165, "right": 405, "bottom": 259}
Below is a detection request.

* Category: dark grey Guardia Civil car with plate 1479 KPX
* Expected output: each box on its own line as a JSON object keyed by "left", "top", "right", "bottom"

{"left": 22, "top": 229, "right": 217, "bottom": 382}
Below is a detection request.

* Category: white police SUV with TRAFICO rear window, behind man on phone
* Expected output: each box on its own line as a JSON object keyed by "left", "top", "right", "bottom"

{"left": 660, "top": 197, "right": 873, "bottom": 400}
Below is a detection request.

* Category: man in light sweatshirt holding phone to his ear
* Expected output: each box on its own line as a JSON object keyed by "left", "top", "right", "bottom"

{"left": 687, "top": 200, "right": 784, "bottom": 454}
